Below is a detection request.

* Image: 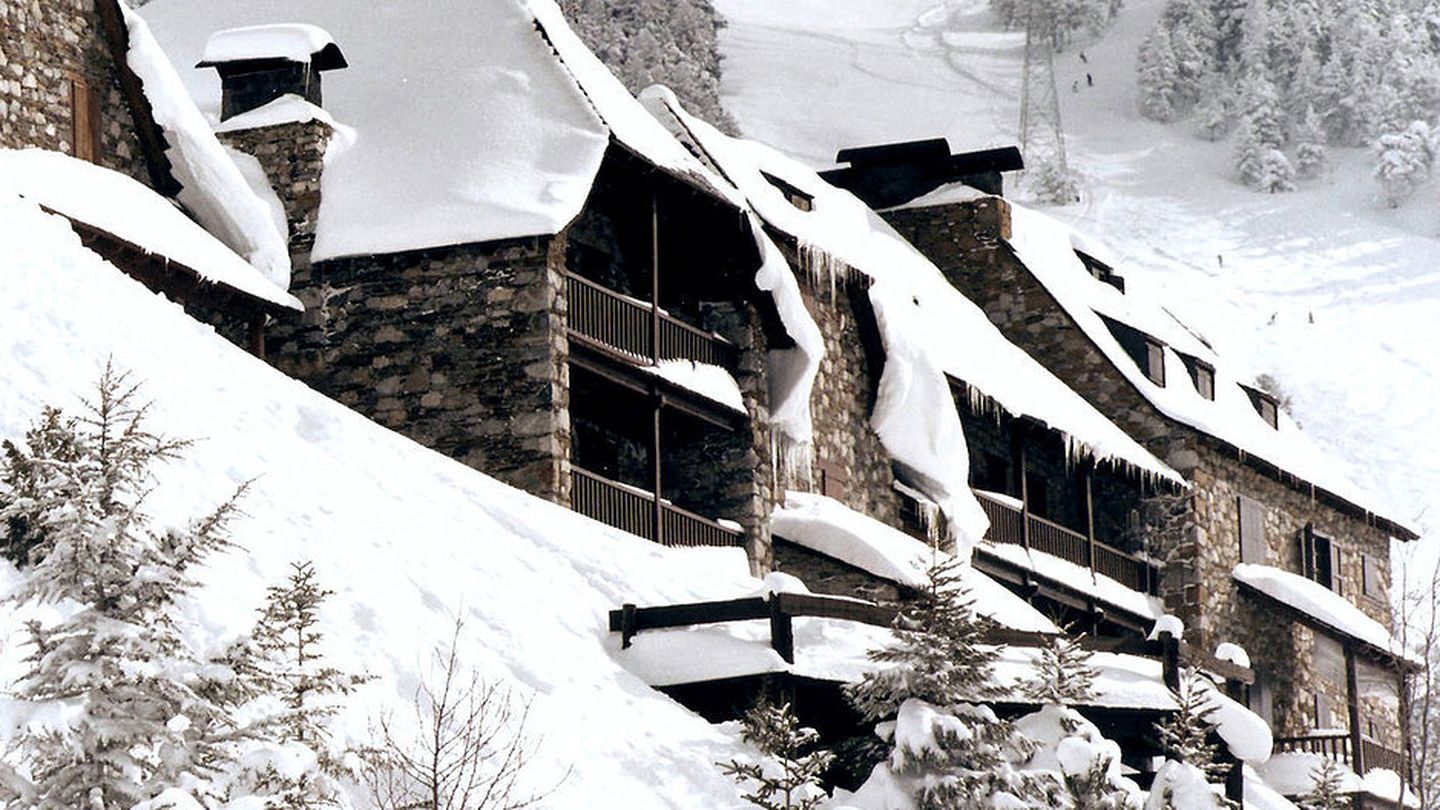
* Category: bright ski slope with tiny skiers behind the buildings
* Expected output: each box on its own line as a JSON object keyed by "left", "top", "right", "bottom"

{"left": 716, "top": 0, "right": 1440, "bottom": 573}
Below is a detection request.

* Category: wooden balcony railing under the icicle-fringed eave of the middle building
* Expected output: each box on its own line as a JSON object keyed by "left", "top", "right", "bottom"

{"left": 975, "top": 491, "right": 1159, "bottom": 594}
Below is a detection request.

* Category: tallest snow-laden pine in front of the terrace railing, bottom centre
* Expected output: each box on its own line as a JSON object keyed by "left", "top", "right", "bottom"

{"left": 845, "top": 558, "right": 1053, "bottom": 809}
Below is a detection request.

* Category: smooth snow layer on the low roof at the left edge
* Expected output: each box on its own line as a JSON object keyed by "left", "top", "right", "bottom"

{"left": 0, "top": 148, "right": 304, "bottom": 310}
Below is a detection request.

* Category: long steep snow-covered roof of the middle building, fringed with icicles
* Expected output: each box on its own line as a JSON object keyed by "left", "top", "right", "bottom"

{"left": 642, "top": 88, "right": 1181, "bottom": 492}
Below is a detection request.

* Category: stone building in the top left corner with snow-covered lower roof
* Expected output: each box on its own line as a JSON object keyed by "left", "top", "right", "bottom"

{"left": 0, "top": 0, "right": 300, "bottom": 341}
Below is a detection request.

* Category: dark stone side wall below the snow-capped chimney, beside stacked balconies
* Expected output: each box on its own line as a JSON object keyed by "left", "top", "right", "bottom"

{"left": 266, "top": 238, "right": 570, "bottom": 503}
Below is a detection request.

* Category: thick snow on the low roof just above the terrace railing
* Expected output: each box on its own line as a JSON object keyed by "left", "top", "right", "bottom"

{"left": 770, "top": 491, "right": 1060, "bottom": 633}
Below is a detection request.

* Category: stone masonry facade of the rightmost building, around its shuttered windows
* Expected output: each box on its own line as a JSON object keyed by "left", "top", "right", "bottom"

{"left": 886, "top": 197, "right": 1401, "bottom": 749}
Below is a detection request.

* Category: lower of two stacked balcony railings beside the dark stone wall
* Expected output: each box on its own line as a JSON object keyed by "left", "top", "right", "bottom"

{"left": 570, "top": 467, "right": 744, "bottom": 546}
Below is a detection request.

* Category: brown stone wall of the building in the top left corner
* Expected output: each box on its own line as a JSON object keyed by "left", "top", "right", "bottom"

{"left": 0, "top": 0, "right": 150, "bottom": 184}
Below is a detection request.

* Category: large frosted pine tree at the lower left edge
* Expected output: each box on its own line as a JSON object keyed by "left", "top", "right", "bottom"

{"left": 6, "top": 365, "right": 243, "bottom": 810}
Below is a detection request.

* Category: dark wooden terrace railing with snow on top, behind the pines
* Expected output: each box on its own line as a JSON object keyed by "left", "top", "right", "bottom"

{"left": 609, "top": 594, "right": 1254, "bottom": 683}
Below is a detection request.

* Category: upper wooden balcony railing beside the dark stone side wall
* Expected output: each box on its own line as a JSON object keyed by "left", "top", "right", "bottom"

{"left": 564, "top": 275, "right": 736, "bottom": 369}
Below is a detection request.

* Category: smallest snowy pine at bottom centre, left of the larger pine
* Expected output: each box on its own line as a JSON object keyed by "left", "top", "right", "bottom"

{"left": 720, "top": 699, "right": 835, "bottom": 810}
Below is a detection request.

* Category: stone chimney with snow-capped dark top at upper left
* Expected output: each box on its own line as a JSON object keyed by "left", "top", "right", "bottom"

{"left": 196, "top": 25, "right": 348, "bottom": 262}
